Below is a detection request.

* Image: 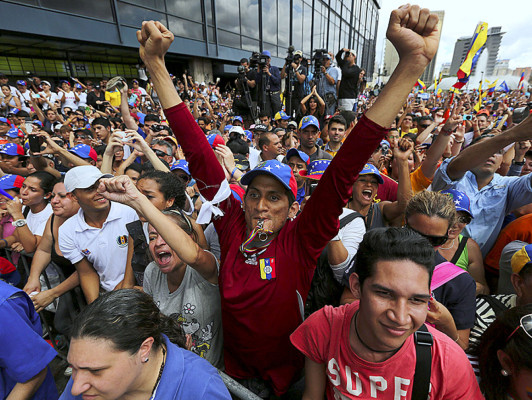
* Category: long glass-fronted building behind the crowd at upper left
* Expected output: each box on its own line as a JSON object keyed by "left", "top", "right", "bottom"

{"left": 0, "top": 0, "right": 380, "bottom": 81}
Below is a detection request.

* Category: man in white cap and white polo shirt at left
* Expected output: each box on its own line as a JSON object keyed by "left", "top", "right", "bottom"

{"left": 59, "top": 165, "right": 138, "bottom": 303}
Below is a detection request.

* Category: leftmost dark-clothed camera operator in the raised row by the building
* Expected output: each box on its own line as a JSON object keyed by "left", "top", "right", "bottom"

{"left": 233, "top": 58, "right": 257, "bottom": 120}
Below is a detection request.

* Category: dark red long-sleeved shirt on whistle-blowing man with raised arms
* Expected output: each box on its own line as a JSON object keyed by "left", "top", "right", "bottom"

{"left": 165, "top": 103, "right": 386, "bottom": 395}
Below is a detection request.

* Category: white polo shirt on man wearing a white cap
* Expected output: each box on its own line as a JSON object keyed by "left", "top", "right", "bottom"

{"left": 59, "top": 202, "right": 139, "bottom": 291}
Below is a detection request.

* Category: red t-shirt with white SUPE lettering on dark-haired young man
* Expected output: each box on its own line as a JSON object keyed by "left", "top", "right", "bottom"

{"left": 290, "top": 302, "right": 484, "bottom": 400}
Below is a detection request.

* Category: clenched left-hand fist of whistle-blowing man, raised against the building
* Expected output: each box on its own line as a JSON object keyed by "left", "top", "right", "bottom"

{"left": 137, "top": 21, "right": 174, "bottom": 65}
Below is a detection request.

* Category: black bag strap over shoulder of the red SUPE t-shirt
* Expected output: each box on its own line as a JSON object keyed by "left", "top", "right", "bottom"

{"left": 411, "top": 324, "right": 434, "bottom": 400}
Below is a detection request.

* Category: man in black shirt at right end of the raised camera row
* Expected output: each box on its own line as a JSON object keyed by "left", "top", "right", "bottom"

{"left": 336, "top": 48, "right": 360, "bottom": 111}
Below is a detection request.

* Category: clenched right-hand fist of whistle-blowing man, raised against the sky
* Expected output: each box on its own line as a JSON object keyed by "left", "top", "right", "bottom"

{"left": 386, "top": 4, "right": 440, "bottom": 64}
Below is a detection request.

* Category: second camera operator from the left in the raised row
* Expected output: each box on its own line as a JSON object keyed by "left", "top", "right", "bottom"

{"left": 256, "top": 50, "right": 282, "bottom": 117}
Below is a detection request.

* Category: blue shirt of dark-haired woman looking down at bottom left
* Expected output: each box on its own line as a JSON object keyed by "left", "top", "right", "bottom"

{"left": 60, "top": 335, "right": 231, "bottom": 400}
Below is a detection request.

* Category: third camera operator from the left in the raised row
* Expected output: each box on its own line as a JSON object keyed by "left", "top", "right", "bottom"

{"left": 281, "top": 50, "right": 308, "bottom": 117}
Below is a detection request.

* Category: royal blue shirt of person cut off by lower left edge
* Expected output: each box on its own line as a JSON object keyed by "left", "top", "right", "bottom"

{"left": 0, "top": 281, "right": 58, "bottom": 400}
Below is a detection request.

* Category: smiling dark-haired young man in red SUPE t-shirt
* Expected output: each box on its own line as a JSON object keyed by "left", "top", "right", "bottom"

{"left": 291, "top": 228, "right": 483, "bottom": 400}
